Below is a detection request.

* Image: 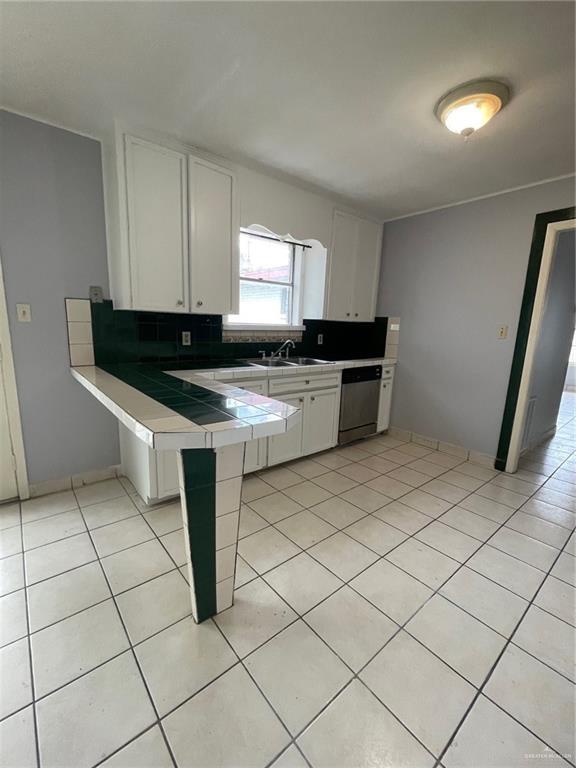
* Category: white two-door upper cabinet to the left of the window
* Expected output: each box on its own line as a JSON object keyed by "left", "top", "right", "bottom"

{"left": 116, "top": 134, "right": 240, "bottom": 315}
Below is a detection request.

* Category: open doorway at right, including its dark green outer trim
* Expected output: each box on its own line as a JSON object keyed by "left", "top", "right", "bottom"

{"left": 495, "top": 207, "right": 576, "bottom": 472}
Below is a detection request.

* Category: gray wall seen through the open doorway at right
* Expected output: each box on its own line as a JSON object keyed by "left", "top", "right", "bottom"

{"left": 526, "top": 231, "right": 576, "bottom": 447}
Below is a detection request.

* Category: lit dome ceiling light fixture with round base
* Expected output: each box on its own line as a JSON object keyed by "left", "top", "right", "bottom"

{"left": 434, "top": 80, "right": 510, "bottom": 138}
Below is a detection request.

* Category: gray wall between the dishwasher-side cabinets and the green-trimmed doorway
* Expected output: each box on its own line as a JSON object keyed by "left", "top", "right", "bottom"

{"left": 378, "top": 179, "right": 574, "bottom": 455}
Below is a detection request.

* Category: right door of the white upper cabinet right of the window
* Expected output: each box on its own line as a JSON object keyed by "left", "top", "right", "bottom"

{"left": 352, "top": 219, "right": 382, "bottom": 322}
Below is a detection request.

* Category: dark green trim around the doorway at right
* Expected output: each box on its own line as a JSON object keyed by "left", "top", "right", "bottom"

{"left": 494, "top": 206, "right": 576, "bottom": 472}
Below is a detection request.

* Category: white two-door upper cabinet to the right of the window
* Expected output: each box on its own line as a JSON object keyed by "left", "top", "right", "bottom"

{"left": 326, "top": 211, "right": 382, "bottom": 322}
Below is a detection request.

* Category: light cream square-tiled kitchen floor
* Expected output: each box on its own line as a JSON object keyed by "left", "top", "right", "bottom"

{"left": 0, "top": 395, "right": 576, "bottom": 768}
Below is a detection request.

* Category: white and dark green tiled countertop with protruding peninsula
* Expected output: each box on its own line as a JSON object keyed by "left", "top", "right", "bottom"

{"left": 71, "top": 359, "right": 396, "bottom": 450}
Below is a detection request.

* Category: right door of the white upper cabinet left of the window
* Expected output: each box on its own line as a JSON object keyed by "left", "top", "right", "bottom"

{"left": 189, "top": 156, "right": 240, "bottom": 315}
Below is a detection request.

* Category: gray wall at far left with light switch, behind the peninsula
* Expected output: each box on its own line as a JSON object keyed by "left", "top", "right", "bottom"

{"left": 0, "top": 110, "right": 120, "bottom": 483}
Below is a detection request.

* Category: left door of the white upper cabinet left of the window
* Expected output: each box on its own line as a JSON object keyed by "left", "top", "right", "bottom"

{"left": 125, "top": 135, "right": 188, "bottom": 312}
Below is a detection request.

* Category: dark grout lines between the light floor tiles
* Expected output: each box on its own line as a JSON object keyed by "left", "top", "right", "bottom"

{"left": 4, "top": 414, "right": 574, "bottom": 765}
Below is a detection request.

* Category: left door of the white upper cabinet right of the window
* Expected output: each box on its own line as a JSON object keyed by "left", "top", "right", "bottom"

{"left": 326, "top": 211, "right": 358, "bottom": 320}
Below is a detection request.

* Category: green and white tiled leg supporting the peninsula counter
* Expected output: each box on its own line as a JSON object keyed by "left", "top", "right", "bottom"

{"left": 178, "top": 443, "right": 244, "bottom": 623}
